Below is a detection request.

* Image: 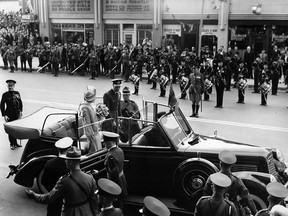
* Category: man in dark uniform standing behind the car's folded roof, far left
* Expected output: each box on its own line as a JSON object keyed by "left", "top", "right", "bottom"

{"left": 0, "top": 80, "right": 23, "bottom": 150}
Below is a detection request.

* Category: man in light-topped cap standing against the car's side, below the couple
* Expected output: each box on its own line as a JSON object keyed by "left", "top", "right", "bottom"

{"left": 102, "top": 131, "right": 128, "bottom": 209}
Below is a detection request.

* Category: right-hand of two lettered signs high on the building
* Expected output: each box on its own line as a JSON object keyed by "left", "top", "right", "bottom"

{"left": 103, "top": 0, "right": 153, "bottom": 14}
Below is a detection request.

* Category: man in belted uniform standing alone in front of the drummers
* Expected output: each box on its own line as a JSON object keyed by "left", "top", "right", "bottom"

{"left": 187, "top": 68, "right": 204, "bottom": 117}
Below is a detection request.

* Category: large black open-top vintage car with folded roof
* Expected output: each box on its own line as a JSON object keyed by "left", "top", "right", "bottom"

{"left": 4, "top": 101, "right": 287, "bottom": 211}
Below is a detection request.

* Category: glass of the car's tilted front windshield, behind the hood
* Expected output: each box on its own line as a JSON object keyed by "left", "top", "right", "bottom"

{"left": 160, "top": 113, "right": 188, "bottom": 146}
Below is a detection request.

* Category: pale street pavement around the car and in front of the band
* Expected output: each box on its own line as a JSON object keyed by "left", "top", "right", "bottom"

{"left": 0, "top": 62, "right": 288, "bottom": 216}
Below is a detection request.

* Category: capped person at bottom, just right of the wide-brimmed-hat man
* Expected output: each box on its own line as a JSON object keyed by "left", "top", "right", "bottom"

{"left": 98, "top": 178, "right": 123, "bottom": 216}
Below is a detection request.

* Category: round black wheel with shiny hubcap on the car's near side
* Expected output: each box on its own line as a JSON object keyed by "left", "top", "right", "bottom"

{"left": 173, "top": 158, "right": 219, "bottom": 198}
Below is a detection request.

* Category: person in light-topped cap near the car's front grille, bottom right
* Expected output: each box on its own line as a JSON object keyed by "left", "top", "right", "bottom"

{"left": 255, "top": 182, "right": 288, "bottom": 216}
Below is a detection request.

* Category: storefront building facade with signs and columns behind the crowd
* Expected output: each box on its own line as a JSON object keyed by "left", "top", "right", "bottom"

{"left": 32, "top": 0, "right": 288, "bottom": 53}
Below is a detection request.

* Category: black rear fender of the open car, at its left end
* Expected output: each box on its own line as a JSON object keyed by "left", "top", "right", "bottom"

{"left": 14, "top": 155, "right": 57, "bottom": 188}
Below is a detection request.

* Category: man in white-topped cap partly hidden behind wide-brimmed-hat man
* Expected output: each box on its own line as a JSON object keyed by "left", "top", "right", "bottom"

{"left": 42, "top": 137, "right": 73, "bottom": 216}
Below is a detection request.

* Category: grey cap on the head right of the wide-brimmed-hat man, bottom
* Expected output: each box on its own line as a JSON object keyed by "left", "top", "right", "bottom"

{"left": 98, "top": 178, "right": 122, "bottom": 196}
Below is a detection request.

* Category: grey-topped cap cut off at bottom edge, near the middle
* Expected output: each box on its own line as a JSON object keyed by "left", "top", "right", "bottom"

{"left": 139, "top": 196, "right": 170, "bottom": 216}
